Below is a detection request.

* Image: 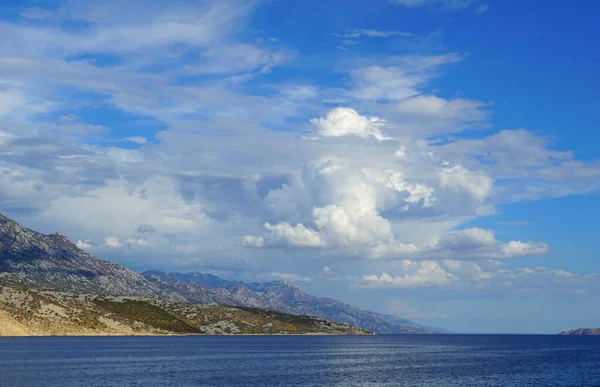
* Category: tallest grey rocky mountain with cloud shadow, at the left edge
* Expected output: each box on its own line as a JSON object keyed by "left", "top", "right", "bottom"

{"left": 0, "top": 214, "right": 185, "bottom": 301}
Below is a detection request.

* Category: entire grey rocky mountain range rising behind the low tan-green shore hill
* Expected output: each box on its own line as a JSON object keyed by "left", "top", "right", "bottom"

{"left": 0, "top": 214, "right": 444, "bottom": 334}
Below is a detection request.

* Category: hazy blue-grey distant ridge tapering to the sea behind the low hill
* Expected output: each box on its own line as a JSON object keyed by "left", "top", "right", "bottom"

{"left": 143, "top": 270, "right": 438, "bottom": 334}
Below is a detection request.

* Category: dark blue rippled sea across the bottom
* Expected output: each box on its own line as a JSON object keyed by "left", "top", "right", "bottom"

{"left": 0, "top": 335, "right": 600, "bottom": 386}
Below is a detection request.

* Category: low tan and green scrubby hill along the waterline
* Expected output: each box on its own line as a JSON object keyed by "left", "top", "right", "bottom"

{"left": 0, "top": 287, "right": 372, "bottom": 336}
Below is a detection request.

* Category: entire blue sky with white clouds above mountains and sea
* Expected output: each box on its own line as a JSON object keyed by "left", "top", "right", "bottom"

{"left": 0, "top": 0, "right": 600, "bottom": 333}
